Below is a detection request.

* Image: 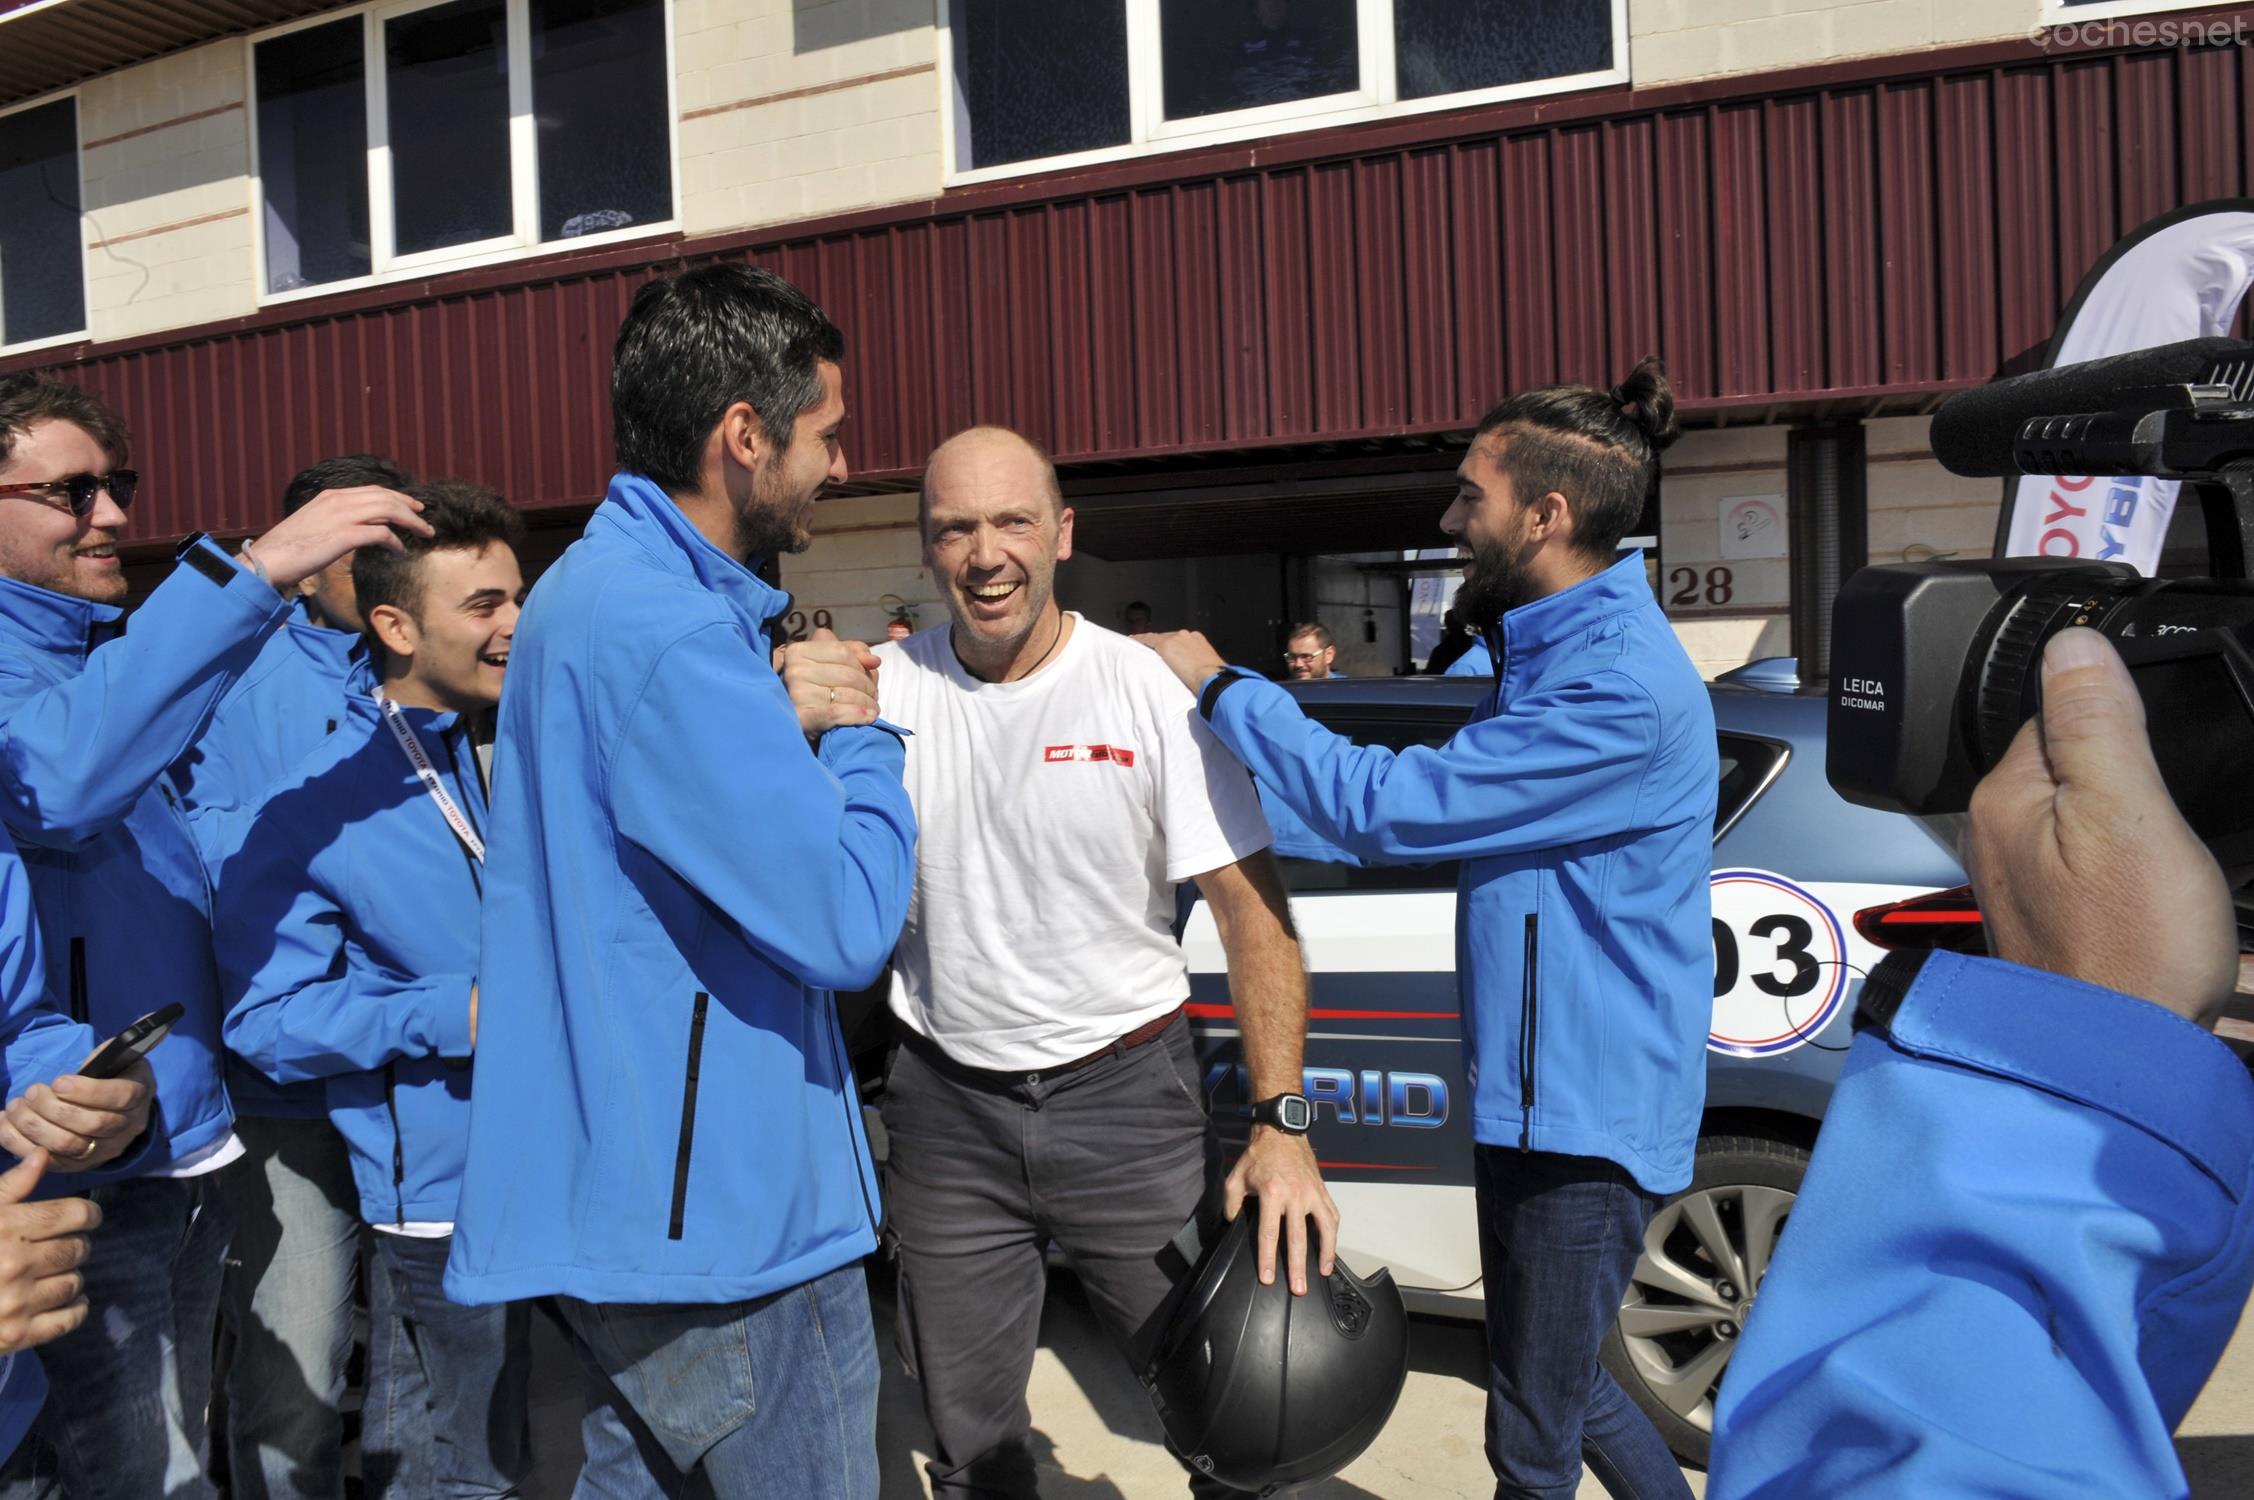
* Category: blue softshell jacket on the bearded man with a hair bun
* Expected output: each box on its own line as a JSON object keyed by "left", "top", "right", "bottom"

{"left": 1201, "top": 557, "right": 1722, "bottom": 1193}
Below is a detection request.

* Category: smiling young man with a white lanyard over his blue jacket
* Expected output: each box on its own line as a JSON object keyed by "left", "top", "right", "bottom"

{"left": 216, "top": 483, "right": 530, "bottom": 1498}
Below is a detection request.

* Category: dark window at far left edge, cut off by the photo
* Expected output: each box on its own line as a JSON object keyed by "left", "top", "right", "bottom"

{"left": 0, "top": 99, "right": 86, "bottom": 347}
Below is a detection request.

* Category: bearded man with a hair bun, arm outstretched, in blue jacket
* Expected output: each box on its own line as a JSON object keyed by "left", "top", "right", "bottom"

{"left": 1156, "top": 361, "right": 1720, "bottom": 1500}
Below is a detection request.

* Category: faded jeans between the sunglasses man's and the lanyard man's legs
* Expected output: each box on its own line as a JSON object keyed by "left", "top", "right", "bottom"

{"left": 225, "top": 1117, "right": 363, "bottom": 1500}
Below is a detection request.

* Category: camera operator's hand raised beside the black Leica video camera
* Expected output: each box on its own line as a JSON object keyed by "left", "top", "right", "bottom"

{"left": 1965, "top": 629, "right": 2238, "bottom": 1026}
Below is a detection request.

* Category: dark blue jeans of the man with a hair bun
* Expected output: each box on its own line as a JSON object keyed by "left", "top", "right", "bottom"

{"left": 1472, "top": 1146, "right": 1691, "bottom": 1500}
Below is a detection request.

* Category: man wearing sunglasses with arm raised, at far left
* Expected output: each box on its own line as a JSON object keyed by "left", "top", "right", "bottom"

{"left": 0, "top": 374, "right": 428, "bottom": 1500}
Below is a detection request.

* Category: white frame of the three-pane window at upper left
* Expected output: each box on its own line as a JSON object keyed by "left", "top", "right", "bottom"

{"left": 243, "top": 0, "right": 681, "bottom": 307}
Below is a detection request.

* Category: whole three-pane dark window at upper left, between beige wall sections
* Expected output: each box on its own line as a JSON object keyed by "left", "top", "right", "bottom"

{"left": 252, "top": 0, "right": 674, "bottom": 295}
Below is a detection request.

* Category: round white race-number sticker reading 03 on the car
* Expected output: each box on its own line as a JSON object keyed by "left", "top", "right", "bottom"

{"left": 1706, "top": 871, "right": 1862, "bottom": 1058}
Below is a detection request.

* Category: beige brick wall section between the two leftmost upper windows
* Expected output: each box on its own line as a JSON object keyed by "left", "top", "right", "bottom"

{"left": 79, "top": 41, "right": 257, "bottom": 338}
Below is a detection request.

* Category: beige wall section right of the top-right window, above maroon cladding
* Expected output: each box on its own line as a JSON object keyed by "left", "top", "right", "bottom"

{"left": 1627, "top": 0, "right": 2044, "bottom": 86}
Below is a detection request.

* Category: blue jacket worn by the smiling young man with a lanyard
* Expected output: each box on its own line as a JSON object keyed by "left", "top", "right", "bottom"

{"left": 216, "top": 665, "right": 489, "bottom": 1225}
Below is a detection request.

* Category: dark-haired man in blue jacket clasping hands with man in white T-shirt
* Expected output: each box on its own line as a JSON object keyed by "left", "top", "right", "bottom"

{"left": 446, "top": 264, "right": 915, "bottom": 1500}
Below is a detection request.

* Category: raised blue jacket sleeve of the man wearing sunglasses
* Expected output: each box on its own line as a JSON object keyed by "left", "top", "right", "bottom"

{"left": 0, "top": 541, "right": 289, "bottom": 848}
